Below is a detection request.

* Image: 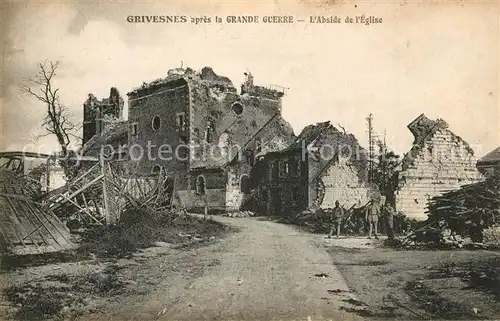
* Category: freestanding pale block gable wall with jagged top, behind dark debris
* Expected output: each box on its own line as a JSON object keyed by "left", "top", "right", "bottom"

{"left": 396, "top": 114, "right": 482, "bottom": 220}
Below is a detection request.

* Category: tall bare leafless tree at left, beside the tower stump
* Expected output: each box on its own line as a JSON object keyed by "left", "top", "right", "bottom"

{"left": 21, "top": 61, "right": 78, "bottom": 174}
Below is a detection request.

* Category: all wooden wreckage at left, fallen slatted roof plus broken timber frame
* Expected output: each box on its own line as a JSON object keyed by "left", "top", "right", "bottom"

{"left": 0, "top": 154, "right": 175, "bottom": 254}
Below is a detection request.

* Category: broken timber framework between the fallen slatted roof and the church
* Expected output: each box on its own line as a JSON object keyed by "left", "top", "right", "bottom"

{"left": 46, "top": 158, "right": 175, "bottom": 225}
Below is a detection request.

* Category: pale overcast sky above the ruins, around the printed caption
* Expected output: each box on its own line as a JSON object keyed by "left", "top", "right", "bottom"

{"left": 0, "top": 2, "right": 500, "bottom": 156}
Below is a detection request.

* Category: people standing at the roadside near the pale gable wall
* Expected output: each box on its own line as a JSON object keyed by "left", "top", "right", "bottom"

{"left": 328, "top": 199, "right": 396, "bottom": 239}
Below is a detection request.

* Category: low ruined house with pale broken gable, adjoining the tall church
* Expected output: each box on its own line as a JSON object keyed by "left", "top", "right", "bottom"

{"left": 253, "top": 122, "right": 373, "bottom": 216}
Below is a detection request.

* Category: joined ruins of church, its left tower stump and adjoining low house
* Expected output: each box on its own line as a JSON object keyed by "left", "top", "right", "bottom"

{"left": 82, "top": 67, "right": 369, "bottom": 215}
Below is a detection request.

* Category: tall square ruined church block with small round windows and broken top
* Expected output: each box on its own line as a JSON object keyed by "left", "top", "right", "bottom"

{"left": 128, "top": 67, "right": 294, "bottom": 211}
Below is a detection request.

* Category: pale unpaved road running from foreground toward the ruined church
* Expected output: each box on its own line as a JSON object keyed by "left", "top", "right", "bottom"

{"left": 91, "top": 217, "right": 360, "bottom": 321}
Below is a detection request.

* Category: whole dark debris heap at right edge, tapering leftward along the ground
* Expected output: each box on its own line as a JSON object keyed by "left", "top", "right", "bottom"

{"left": 387, "top": 174, "right": 500, "bottom": 249}
